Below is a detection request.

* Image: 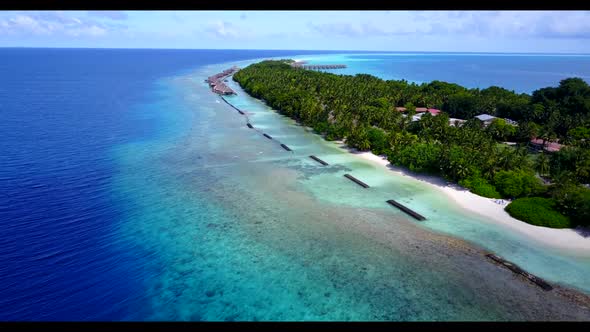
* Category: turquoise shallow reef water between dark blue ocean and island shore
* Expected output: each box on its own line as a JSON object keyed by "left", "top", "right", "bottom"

{"left": 106, "top": 58, "right": 590, "bottom": 320}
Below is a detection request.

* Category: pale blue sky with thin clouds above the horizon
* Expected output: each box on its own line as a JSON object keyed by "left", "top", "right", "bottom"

{"left": 0, "top": 11, "right": 590, "bottom": 53}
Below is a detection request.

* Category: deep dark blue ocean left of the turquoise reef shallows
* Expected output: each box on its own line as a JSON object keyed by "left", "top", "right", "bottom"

{"left": 0, "top": 49, "right": 342, "bottom": 320}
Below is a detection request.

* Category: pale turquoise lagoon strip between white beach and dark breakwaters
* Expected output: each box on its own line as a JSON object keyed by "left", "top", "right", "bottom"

{"left": 222, "top": 59, "right": 590, "bottom": 292}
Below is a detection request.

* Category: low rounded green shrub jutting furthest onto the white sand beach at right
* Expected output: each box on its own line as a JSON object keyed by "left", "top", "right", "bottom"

{"left": 506, "top": 197, "right": 571, "bottom": 228}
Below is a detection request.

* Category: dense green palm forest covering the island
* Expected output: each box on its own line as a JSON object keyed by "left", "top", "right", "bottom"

{"left": 234, "top": 61, "right": 590, "bottom": 225}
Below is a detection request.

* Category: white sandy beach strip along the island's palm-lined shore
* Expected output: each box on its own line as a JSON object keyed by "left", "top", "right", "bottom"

{"left": 349, "top": 149, "right": 590, "bottom": 251}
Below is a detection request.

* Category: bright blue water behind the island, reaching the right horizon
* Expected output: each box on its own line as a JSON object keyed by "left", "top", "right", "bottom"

{"left": 300, "top": 52, "right": 590, "bottom": 94}
